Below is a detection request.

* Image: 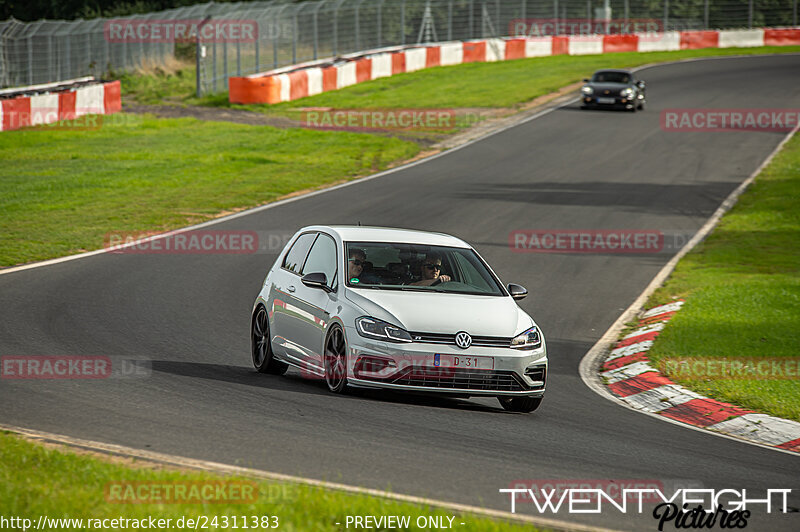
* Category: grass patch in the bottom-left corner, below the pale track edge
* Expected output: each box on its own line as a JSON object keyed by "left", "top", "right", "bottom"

{"left": 0, "top": 433, "right": 534, "bottom": 532}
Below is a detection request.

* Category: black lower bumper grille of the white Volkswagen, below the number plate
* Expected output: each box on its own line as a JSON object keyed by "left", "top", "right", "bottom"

{"left": 391, "top": 367, "right": 530, "bottom": 392}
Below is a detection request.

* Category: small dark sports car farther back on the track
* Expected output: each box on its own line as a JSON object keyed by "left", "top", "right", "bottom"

{"left": 581, "top": 70, "right": 646, "bottom": 112}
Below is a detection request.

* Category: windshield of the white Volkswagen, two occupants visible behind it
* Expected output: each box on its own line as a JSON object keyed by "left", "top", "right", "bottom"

{"left": 345, "top": 242, "right": 505, "bottom": 296}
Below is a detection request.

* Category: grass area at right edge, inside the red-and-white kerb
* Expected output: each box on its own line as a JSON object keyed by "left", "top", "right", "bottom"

{"left": 648, "top": 135, "right": 800, "bottom": 421}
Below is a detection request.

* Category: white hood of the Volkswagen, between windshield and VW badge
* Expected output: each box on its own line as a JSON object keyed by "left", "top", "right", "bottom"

{"left": 347, "top": 289, "right": 534, "bottom": 337}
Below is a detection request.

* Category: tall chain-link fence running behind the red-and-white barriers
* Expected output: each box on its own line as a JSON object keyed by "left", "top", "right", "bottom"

{"left": 0, "top": 0, "right": 798, "bottom": 93}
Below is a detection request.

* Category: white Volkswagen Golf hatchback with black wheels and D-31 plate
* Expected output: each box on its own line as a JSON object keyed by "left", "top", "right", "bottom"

{"left": 251, "top": 226, "right": 547, "bottom": 412}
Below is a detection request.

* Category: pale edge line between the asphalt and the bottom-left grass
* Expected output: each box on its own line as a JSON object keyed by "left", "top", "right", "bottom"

{"left": 0, "top": 424, "right": 613, "bottom": 532}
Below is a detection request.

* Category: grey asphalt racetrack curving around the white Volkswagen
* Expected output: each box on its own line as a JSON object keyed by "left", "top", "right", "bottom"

{"left": 0, "top": 55, "right": 800, "bottom": 530}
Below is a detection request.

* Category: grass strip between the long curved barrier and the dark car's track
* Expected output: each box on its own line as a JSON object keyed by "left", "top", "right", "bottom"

{"left": 115, "top": 46, "right": 800, "bottom": 112}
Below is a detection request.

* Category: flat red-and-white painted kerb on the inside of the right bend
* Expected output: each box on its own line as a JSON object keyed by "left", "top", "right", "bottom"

{"left": 600, "top": 301, "right": 800, "bottom": 453}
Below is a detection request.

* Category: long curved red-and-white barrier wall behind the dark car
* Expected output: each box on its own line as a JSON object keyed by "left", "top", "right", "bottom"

{"left": 228, "top": 28, "right": 800, "bottom": 104}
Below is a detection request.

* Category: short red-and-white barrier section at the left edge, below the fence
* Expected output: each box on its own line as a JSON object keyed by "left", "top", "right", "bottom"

{"left": 0, "top": 78, "right": 122, "bottom": 131}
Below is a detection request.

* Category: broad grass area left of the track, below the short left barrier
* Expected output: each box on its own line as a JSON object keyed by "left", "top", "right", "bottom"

{"left": 0, "top": 115, "right": 419, "bottom": 266}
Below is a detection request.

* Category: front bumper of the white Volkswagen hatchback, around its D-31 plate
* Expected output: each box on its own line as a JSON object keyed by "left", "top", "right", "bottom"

{"left": 345, "top": 327, "right": 548, "bottom": 397}
